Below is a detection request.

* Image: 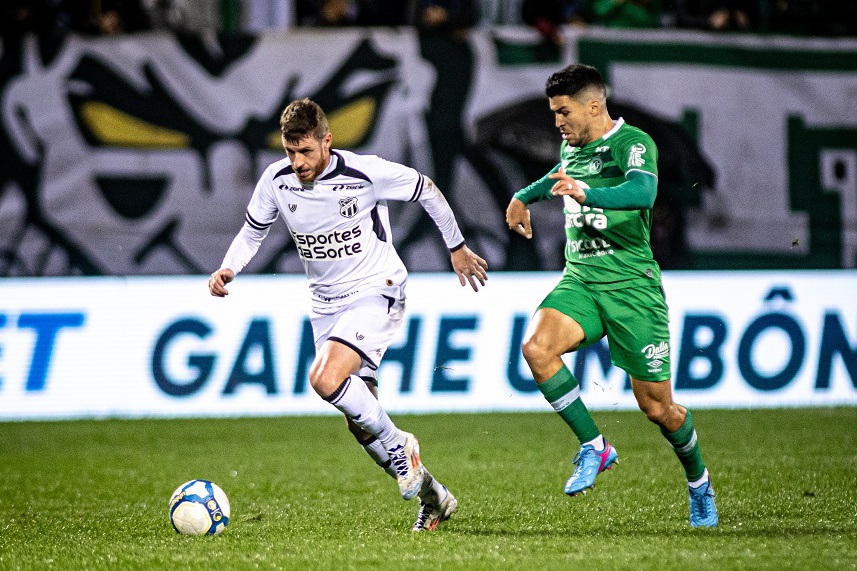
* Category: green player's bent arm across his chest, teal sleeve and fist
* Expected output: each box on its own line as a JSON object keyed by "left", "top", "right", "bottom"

{"left": 551, "top": 170, "right": 658, "bottom": 210}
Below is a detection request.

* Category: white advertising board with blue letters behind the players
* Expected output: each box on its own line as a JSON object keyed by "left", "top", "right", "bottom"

{"left": 0, "top": 271, "right": 857, "bottom": 420}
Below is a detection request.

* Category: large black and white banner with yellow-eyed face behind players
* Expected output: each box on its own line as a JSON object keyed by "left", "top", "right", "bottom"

{"left": 0, "top": 28, "right": 857, "bottom": 276}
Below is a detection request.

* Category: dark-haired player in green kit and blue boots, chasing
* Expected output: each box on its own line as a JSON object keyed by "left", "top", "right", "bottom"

{"left": 506, "top": 65, "right": 718, "bottom": 527}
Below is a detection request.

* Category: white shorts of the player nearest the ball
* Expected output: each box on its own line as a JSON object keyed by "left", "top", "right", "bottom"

{"left": 310, "top": 290, "right": 405, "bottom": 379}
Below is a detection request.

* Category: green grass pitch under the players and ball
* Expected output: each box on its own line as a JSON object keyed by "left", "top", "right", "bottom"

{"left": 0, "top": 408, "right": 857, "bottom": 571}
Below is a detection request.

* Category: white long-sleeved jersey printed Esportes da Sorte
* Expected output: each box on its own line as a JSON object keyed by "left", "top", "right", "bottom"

{"left": 221, "top": 150, "right": 464, "bottom": 307}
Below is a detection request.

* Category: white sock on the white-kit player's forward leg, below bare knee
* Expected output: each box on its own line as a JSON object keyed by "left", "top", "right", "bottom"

{"left": 326, "top": 375, "right": 405, "bottom": 450}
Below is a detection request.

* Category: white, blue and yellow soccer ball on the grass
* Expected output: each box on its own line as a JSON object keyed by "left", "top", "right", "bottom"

{"left": 170, "top": 480, "right": 229, "bottom": 535}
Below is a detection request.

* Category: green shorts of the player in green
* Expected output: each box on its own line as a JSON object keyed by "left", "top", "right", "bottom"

{"left": 539, "top": 276, "right": 671, "bottom": 381}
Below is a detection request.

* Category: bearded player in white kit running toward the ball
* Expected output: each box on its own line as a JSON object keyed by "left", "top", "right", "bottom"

{"left": 208, "top": 99, "right": 488, "bottom": 531}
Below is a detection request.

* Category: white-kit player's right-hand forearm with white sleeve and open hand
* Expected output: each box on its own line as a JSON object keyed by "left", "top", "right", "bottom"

{"left": 419, "top": 175, "right": 488, "bottom": 291}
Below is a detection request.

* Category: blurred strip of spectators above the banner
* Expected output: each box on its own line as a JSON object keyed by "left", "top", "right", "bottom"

{"left": 0, "top": 0, "right": 857, "bottom": 42}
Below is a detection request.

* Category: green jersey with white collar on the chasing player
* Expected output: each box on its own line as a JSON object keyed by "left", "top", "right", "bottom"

{"left": 515, "top": 119, "right": 661, "bottom": 290}
